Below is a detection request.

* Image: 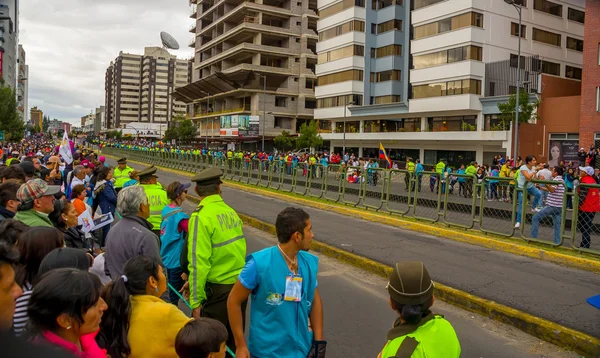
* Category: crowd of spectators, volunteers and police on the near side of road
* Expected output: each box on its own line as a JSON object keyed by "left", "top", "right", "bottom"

{"left": 0, "top": 136, "right": 461, "bottom": 358}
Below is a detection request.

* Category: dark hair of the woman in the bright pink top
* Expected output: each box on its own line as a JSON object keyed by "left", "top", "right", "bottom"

{"left": 27, "top": 268, "right": 102, "bottom": 333}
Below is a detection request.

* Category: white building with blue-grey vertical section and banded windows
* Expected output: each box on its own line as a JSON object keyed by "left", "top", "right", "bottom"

{"left": 315, "top": 0, "right": 585, "bottom": 164}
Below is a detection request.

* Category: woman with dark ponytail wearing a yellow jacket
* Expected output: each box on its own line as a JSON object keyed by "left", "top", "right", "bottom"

{"left": 98, "top": 255, "right": 190, "bottom": 358}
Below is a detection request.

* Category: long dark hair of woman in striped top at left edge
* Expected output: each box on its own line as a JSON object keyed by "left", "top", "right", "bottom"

{"left": 16, "top": 226, "right": 64, "bottom": 287}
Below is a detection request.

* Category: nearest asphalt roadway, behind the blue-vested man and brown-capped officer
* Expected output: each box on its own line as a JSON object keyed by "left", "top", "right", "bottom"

{"left": 178, "top": 202, "right": 578, "bottom": 358}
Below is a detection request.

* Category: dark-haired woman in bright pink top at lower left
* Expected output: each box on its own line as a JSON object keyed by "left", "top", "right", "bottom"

{"left": 28, "top": 268, "right": 107, "bottom": 358}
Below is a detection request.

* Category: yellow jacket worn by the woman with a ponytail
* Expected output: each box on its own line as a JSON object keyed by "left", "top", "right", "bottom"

{"left": 127, "top": 295, "right": 190, "bottom": 358}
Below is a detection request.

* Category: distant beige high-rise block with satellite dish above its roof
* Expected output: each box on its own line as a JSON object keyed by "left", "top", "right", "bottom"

{"left": 105, "top": 47, "right": 191, "bottom": 129}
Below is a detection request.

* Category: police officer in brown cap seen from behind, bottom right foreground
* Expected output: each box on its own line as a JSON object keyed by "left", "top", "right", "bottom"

{"left": 378, "top": 262, "right": 461, "bottom": 358}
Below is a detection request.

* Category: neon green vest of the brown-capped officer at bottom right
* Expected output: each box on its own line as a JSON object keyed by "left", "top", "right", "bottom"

{"left": 381, "top": 313, "right": 461, "bottom": 358}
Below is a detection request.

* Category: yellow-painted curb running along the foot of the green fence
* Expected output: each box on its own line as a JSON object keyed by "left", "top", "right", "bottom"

{"left": 105, "top": 154, "right": 600, "bottom": 273}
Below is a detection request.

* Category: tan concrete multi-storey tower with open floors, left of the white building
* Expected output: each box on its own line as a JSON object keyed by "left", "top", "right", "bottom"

{"left": 176, "top": 0, "right": 318, "bottom": 149}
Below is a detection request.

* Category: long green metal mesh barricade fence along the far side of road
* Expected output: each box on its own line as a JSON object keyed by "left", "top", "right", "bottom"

{"left": 103, "top": 147, "right": 600, "bottom": 256}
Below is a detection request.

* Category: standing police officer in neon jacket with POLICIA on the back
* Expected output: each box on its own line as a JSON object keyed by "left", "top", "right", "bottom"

{"left": 187, "top": 168, "right": 246, "bottom": 352}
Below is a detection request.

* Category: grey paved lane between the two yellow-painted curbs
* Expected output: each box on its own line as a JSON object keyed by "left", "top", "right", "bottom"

{"left": 109, "top": 160, "right": 600, "bottom": 337}
